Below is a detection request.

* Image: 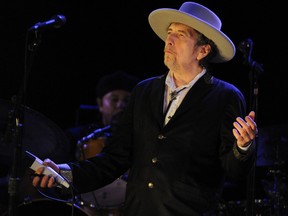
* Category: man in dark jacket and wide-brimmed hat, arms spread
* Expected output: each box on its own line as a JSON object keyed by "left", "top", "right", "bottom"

{"left": 33, "top": 2, "right": 257, "bottom": 216}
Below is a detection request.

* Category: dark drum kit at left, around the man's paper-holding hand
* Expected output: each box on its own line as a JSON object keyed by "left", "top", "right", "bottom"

{"left": 0, "top": 99, "right": 126, "bottom": 216}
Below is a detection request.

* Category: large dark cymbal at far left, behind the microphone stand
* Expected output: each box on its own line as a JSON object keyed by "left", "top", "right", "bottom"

{"left": 0, "top": 99, "right": 71, "bottom": 170}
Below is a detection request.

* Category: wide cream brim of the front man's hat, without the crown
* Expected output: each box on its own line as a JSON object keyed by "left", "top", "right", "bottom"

{"left": 148, "top": 8, "right": 235, "bottom": 62}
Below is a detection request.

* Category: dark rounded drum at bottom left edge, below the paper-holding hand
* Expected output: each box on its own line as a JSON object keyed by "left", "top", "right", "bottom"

{"left": 3, "top": 198, "right": 98, "bottom": 216}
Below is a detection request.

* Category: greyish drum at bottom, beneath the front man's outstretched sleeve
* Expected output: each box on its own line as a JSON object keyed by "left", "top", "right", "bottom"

{"left": 80, "top": 178, "right": 127, "bottom": 216}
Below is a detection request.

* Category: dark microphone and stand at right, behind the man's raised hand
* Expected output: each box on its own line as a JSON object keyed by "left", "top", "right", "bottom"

{"left": 239, "top": 38, "right": 264, "bottom": 216}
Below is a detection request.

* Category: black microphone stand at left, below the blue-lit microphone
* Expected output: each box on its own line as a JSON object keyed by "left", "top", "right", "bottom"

{"left": 8, "top": 27, "right": 41, "bottom": 216}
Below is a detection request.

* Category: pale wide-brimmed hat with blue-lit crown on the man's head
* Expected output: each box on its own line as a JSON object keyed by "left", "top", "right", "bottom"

{"left": 148, "top": 2, "right": 236, "bottom": 62}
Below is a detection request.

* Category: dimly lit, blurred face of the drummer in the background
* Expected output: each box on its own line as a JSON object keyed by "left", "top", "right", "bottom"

{"left": 97, "top": 90, "right": 130, "bottom": 125}
